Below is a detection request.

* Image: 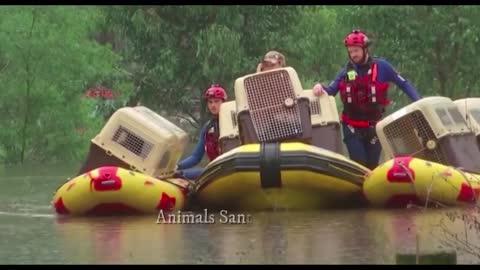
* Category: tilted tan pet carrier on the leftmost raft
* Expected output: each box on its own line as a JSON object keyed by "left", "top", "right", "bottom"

{"left": 79, "top": 106, "right": 188, "bottom": 178}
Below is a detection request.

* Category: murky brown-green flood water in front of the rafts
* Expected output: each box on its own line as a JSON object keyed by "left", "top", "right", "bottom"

{"left": 0, "top": 162, "right": 480, "bottom": 264}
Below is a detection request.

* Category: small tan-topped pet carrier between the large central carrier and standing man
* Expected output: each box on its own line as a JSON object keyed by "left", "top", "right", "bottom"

{"left": 301, "top": 89, "right": 343, "bottom": 154}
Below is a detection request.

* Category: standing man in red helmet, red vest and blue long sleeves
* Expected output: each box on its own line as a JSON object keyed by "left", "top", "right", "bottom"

{"left": 313, "top": 30, "right": 421, "bottom": 169}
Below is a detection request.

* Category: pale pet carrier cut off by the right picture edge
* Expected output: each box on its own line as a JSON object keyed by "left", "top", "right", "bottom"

{"left": 454, "top": 98, "right": 480, "bottom": 147}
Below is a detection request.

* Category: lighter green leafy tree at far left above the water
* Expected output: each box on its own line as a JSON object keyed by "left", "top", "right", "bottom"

{"left": 0, "top": 6, "right": 129, "bottom": 163}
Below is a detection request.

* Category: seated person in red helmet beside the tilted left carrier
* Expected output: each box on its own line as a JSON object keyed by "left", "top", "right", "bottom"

{"left": 177, "top": 84, "right": 227, "bottom": 180}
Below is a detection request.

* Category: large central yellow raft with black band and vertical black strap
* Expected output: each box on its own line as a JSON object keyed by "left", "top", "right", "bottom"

{"left": 195, "top": 142, "right": 369, "bottom": 210}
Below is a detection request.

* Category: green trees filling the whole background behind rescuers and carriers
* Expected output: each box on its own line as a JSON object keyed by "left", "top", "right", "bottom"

{"left": 0, "top": 6, "right": 480, "bottom": 163}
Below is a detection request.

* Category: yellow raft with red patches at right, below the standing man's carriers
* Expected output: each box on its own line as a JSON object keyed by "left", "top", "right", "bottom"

{"left": 363, "top": 157, "right": 480, "bottom": 207}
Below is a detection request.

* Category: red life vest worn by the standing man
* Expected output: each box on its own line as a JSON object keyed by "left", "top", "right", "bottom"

{"left": 338, "top": 61, "right": 390, "bottom": 127}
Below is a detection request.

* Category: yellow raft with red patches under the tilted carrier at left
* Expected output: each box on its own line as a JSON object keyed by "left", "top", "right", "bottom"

{"left": 52, "top": 166, "right": 189, "bottom": 215}
